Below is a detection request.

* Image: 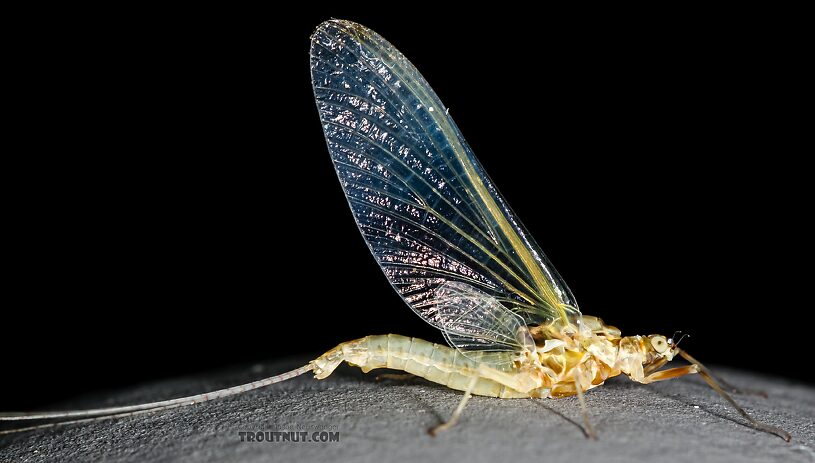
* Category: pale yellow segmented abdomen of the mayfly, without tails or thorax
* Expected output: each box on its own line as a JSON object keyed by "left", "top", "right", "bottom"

{"left": 312, "top": 334, "right": 529, "bottom": 398}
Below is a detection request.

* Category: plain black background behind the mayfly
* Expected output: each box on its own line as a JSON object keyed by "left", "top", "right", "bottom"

{"left": 0, "top": 5, "right": 811, "bottom": 409}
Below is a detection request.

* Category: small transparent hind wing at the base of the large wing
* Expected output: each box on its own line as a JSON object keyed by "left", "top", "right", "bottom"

{"left": 432, "top": 282, "right": 535, "bottom": 366}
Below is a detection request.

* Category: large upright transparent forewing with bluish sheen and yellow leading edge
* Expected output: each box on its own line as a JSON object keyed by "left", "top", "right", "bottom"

{"left": 311, "top": 20, "right": 580, "bottom": 338}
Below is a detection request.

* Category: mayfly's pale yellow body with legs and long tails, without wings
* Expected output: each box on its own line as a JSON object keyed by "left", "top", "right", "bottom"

{"left": 0, "top": 316, "right": 791, "bottom": 442}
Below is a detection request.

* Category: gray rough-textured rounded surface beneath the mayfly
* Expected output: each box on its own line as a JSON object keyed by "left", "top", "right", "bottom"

{"left": 0, "top": 359, "right": 815, "bottom": 463}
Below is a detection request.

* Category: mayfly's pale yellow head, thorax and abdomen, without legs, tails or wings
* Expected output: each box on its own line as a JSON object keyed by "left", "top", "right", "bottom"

{"left": 311, "top": 317, "right": 673, "bottom": 398}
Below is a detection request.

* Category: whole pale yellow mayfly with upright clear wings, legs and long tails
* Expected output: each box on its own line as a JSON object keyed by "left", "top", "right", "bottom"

{"left": 0, "top": 20, "right": 790, "bottom": 440}
